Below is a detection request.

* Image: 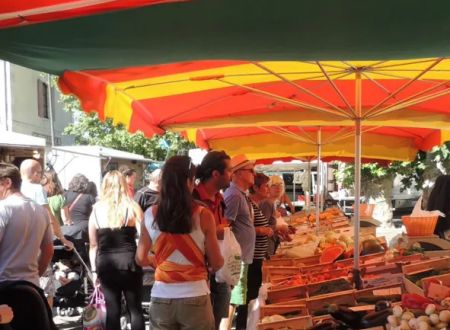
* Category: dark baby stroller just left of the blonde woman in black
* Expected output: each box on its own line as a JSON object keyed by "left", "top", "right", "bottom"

{"left": 52, "top": 237, "right": 93, "bottom": 316}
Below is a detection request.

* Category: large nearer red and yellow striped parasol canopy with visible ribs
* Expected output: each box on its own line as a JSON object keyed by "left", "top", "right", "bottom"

{"left": 59, "top": 58, "right": 450, "bottom": 135}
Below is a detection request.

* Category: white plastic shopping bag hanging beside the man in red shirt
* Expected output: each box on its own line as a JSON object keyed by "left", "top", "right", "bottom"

{"left": 216, "top": 227, "right": 241, "bottom": 286}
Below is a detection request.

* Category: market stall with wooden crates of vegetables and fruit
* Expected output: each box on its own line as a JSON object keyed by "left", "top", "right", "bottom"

{"left": 253, "top": 209, "right": 450, "bottom": 329}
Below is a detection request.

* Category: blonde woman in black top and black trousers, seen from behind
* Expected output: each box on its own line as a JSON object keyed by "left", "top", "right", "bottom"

{"left": 89, "top": 171, "right": 145, "bottom": 330}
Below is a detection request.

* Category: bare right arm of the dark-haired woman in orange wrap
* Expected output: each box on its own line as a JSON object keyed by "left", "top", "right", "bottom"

{"left": 200, "top": 208, "right": 224, "bottom": 272}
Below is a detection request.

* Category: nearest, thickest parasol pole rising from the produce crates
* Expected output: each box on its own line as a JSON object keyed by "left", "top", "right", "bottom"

{"left": 353, "top": 71, "right": 362, "bottom": 289}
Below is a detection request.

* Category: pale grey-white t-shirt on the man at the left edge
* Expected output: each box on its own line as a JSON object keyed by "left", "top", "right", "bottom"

{"left": 0, "top": 195, "right": 53, "bottom": 286}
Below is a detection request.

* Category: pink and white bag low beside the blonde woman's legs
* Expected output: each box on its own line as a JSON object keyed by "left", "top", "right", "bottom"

{"left": 83, "top": 287, "right": 106, "bottom": 330}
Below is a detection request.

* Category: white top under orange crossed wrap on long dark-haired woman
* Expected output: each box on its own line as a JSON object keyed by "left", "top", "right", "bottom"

{"left": 144, "top": 207, "right": 210, "bottom": 299}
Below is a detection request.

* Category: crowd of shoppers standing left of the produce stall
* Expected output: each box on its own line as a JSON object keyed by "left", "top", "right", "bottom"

{"left": 0, "top": 151, "right": 296, "bottom": 330}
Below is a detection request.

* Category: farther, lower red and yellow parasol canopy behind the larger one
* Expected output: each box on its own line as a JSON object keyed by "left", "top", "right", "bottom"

{"left": 184, "top": 126, "right": 450, "bottom": 163}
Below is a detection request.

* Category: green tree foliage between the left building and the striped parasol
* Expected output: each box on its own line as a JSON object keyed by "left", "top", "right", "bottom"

{"left": 54, "top": 82, "right": 194, "bottom": 160}
